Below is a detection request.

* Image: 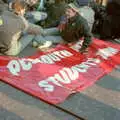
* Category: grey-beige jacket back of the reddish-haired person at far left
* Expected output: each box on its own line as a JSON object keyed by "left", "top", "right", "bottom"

{"left": 0, "top": 11, "right": 25, "bottom": 54}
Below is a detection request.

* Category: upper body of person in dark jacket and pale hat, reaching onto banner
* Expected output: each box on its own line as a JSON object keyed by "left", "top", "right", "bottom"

{"left": 59, "top": 3, "right": 92, "bottom": 52}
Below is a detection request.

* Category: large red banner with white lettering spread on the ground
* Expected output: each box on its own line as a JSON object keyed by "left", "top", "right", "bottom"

{"left": 0, "top": 39, "right": 120, "bottom": 104}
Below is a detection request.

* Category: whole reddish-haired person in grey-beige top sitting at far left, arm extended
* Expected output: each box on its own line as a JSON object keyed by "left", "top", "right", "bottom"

{"left": 0, "top": 0, "right": 46, "bottom": 56}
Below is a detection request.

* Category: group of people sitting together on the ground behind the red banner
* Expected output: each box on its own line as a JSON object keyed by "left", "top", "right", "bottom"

{"left": 0, "top": 0, "right": 120, "bottom": 56}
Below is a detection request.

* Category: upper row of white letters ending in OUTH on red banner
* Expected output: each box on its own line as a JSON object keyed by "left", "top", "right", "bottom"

{"left": 7, "top": 50, "right": 73, "bottom": 76}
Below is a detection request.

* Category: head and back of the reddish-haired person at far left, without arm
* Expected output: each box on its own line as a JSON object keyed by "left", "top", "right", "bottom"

{"left": 0, "top": 0, "right": 27, "bottom": 55}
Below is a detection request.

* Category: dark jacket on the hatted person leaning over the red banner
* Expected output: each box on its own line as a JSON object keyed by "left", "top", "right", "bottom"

{"left": 61, "top": 15, "right": 92, "bottom": 50}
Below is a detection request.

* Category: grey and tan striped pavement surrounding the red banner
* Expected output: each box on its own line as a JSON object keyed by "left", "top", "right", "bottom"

{"left": 0, "top": 39, "right": 120, "bottom": 120}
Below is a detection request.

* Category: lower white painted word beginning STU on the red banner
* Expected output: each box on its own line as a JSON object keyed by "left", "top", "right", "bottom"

{"left": 39, "top": 58, "right": 100, "bottom": 92}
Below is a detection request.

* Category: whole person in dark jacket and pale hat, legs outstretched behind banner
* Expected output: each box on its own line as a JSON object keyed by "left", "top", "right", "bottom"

{"left": 33, "top": 3, "right": 92, "bottom": 53}
